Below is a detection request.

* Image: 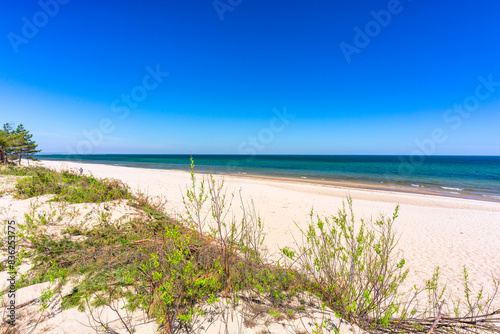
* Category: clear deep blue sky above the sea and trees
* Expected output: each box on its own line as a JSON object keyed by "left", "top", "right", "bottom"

{"left": 0, "top": 0, "right": 500, "bottom": 155}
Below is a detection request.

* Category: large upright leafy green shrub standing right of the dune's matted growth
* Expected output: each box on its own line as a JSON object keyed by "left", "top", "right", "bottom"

{"left": 300, "top": 198, "right": 408, "bottom": 327}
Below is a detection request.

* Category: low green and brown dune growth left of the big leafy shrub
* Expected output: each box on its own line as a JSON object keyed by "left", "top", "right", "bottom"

{"left": 3, "top": 167, "right": 299, "bottom": 332}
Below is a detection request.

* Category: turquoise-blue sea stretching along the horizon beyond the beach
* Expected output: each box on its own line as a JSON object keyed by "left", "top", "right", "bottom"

{"left": 37, "top": 154, "right": 500, "bottom": 200}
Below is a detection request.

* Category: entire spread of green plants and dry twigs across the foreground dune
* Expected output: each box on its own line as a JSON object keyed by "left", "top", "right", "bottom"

{"left": 0, "top": 161, "right": 500, "bottom": 333}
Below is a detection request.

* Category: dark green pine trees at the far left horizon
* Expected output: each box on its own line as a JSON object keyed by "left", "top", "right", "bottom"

{"left": 0, "top": 123, "right": 41, "bottom": 164}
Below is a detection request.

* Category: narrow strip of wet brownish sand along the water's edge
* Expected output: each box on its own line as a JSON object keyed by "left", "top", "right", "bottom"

{"left": 40, "top": 159, "right": 500, "bottom": 203}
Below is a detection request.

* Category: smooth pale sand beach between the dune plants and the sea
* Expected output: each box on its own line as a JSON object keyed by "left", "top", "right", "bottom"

{"left": 38, "top": 161, "right": 500, "bottom": 295}
